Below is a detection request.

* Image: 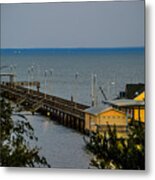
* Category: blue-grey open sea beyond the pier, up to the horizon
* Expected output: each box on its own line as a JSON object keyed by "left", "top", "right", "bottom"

{"left": 1, "top": 49, "right": 144, "bottom": 105}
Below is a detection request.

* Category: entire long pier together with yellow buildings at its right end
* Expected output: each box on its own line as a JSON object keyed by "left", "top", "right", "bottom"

{"left": 0, "top": 73, "right": 145, "bottom": 137}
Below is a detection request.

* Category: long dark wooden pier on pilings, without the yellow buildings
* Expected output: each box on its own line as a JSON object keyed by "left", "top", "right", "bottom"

{"left": 0, "top": 82, "right": 89, "bottom": 133}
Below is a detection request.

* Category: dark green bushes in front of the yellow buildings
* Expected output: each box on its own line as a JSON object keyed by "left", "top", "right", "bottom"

{"left": 86, "top": 121, "right": 145, "bottom": 170}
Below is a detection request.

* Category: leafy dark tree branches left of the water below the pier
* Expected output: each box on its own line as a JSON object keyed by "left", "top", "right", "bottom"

{"left": 0, "top": 99, "right": 50, "bottom": 167}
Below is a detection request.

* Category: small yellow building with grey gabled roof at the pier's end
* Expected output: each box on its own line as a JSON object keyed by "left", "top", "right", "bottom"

{"left": 85, "top": 105, "right": 128, "bottom": 132}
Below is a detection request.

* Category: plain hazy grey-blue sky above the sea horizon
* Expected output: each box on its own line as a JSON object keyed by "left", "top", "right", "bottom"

{"left": 1, "top": 1, "right": 144, "bottom": 48}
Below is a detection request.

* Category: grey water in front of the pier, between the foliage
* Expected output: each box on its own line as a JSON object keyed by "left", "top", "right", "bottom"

{"left": 27, "top": 115, "right": 90, "bottom": 169}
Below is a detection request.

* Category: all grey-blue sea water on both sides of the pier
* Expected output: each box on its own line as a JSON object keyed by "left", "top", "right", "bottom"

{"left": 1, "top": 49, "right": 145, "bottom": 168}
